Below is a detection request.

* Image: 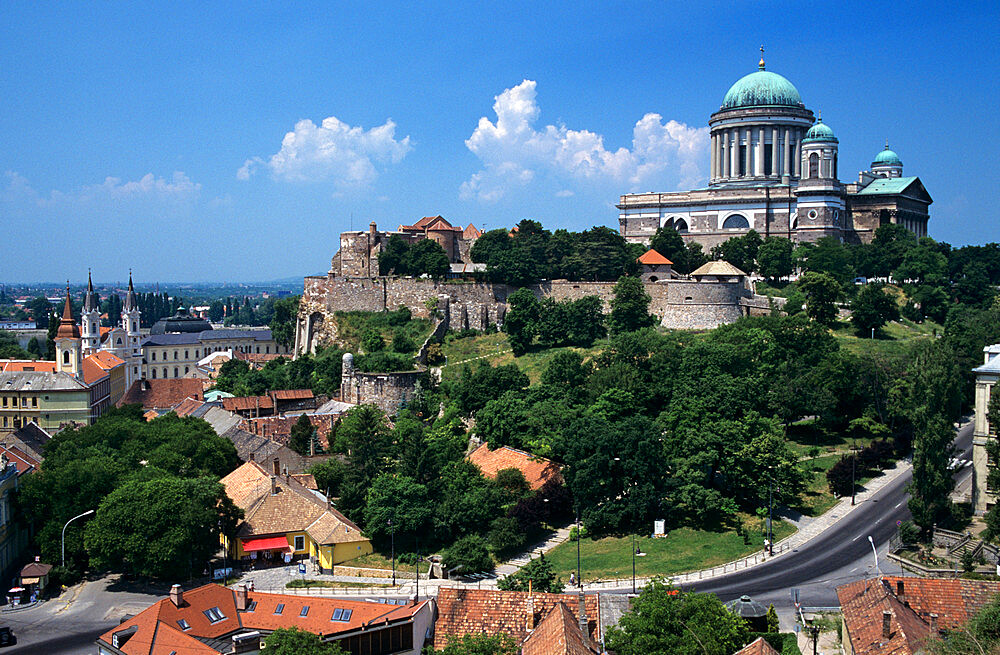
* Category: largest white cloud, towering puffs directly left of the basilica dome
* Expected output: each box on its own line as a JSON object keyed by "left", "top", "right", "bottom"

{"left": 460, "top": 80, "right": 709, "bottom": 202}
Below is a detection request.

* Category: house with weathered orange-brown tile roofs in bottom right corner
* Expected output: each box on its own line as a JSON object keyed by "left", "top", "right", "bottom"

{"left": 837, "top": 576, "right": 1000, "bottom": 655}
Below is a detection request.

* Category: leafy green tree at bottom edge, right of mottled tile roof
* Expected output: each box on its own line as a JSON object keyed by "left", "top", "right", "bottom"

{"left": 607, "top": 578, "right": 749, "bottom": 655}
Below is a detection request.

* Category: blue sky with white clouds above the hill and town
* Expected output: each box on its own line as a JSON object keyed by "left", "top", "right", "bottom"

{"left": 0, "top": 1, "right": 1000, "bottom": 282}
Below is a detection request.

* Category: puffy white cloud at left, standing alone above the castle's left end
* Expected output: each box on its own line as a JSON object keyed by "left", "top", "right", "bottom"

{"left": 236, "top": 116, "right": 413, "bottom": 188}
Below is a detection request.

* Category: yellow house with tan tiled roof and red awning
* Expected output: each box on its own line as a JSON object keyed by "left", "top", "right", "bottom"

{"left": 221, "top": 461, "right": 372, "bottom": 571}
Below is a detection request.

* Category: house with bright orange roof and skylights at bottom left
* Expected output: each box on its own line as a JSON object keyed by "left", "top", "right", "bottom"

{"left": 97, "top": 584, "right": 434, "bottom": 655}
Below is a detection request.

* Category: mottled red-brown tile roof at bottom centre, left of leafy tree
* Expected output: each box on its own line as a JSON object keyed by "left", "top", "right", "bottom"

{"left": 434, "top": 587, "right": 601, "bottom": 649}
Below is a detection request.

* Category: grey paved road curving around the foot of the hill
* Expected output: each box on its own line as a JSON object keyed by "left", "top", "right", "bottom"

{"left": 664, "top": 424, "right": 972, "bottom": 610}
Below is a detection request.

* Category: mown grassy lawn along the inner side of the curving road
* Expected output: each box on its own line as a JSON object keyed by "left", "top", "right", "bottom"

{"left": 545, "top": 521, "right": 795, "bottom": 582}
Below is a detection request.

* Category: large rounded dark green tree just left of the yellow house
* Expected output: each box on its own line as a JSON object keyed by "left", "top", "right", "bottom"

{"left": 84, "top": 477, "right": 243, "bottom": 579}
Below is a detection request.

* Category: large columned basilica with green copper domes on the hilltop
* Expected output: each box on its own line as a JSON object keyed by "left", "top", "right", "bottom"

{"left": 617, "top": 57, "right": 932, "bottom": 250}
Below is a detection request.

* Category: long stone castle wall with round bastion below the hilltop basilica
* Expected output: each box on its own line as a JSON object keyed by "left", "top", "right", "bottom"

{"left": 295, "top": 275, "right": 769, "bottom": 352}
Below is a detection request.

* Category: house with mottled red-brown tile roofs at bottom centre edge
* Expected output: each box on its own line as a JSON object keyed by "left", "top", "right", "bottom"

{"left": 434, "top": 587, "right": 603, "bottom": 655}
